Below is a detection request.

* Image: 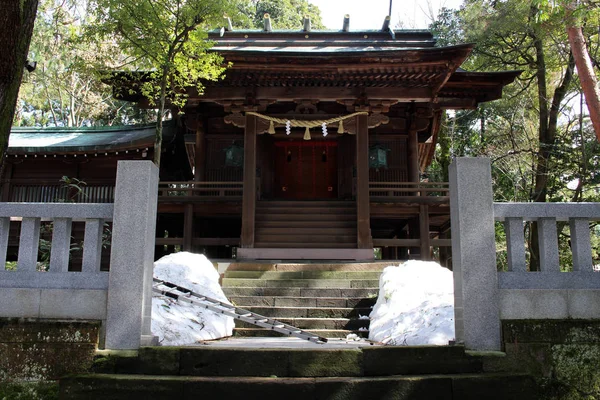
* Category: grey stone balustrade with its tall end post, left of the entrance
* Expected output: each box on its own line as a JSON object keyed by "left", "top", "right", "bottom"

{"left": 0, "top": 161, "right": 158, "bottom": 349}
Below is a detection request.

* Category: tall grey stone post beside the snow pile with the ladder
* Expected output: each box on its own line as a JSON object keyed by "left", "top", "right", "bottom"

{"left": 105, "top": 161, "right": 158, "bottom": 349}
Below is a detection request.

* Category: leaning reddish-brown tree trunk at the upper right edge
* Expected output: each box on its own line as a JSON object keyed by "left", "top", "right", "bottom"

{"left": 567, "top": 26, "right": 600, "bottom": 141}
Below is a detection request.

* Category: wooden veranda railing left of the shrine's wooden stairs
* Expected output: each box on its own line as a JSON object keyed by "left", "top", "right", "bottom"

{"left": 158, "top": 181, "right": 243, "bottom": 198}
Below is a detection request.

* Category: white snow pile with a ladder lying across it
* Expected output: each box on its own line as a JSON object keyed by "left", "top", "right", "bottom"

{"left": 152, "top": 252, "right": 234, "bottom": 346}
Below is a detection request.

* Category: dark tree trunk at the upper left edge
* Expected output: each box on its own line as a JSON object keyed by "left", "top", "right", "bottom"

{"left": 0, "top": 0, "right": 38, "bottom": 164}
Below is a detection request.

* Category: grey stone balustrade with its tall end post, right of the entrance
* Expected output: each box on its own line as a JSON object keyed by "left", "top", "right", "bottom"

{"left": 450, "top": 158, "right": 600, "bottom": 350}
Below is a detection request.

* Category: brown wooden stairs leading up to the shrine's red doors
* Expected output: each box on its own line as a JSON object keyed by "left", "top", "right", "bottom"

{"left": 254, "top": 201, "right": 356, "bottom": 249}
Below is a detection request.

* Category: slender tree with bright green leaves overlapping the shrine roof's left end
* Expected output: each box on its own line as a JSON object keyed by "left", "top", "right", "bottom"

{"left": 90, "top": 0, "right": 233, "bottom": 165}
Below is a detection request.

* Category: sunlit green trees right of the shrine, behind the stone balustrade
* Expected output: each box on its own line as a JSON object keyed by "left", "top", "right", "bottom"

{"left": 429, "top": 0, "right": 600, "bottom": 270}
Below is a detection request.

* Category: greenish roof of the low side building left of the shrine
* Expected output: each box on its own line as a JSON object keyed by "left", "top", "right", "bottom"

{"left": 8, "top": 124, "right": 173, "bottom": 154}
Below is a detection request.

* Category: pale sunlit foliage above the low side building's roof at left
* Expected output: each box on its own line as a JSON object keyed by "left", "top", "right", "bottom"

{"left": 13, "top": 0, "right": 148, "bottom": 127}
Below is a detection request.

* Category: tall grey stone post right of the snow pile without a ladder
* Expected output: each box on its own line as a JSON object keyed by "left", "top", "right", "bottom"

{"left": 450, "top": 158, "right": 501, "bottom": 350}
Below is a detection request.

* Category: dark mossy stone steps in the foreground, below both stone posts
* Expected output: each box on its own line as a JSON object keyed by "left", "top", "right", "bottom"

{"left": 60, "top": 346, "right": 537, "bottom": 400}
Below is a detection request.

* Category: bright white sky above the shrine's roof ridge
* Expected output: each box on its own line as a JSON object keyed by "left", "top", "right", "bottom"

{"left": 308, "top": 0, "right": 462, "bottom": 30}
